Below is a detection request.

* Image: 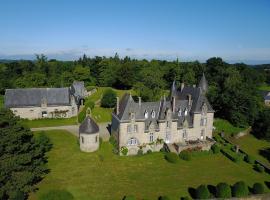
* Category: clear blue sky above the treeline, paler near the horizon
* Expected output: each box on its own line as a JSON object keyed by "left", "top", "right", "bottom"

{"left": 0, "top": 0, "right": 270, "bottom": 64}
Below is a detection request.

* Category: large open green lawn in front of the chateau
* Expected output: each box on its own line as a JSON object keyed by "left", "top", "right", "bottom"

{"left": 30, "top": 131, "right": 270, "bottom": 200}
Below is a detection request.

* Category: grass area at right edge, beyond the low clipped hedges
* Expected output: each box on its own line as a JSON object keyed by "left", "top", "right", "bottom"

{"left": 230, "top": 134, "right": 270, "bottom": 167}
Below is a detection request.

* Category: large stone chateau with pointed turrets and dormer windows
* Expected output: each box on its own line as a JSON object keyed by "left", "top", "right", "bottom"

{"left": 111, "top": 74, "right": 214, "bottom": 155}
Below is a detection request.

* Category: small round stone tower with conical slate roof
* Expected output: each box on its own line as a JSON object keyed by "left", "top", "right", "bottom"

{"left": 79, "top": 111, "right": 99, "bottom": 152}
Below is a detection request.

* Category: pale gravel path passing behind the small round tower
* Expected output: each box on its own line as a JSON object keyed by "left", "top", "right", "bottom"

{"left": 31, "top": 122, "right": 110, "bottom": 141}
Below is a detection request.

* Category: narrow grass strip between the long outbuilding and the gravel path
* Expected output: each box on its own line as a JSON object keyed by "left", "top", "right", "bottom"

{"left": 22, "top": 117, "right": 77, "bottom": 128}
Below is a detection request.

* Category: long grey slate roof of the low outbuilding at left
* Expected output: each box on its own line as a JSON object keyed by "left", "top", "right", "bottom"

{"left": 5, "top": 88, "right": 70, "bottom": 108}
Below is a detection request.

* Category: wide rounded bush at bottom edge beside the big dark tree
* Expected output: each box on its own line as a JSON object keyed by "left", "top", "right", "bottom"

{"left": 40, "top": 190, "right": 74, "bottom": 200}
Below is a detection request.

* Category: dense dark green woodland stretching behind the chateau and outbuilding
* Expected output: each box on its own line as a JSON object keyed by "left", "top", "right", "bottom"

{"left": 0, "top": 54, "right": 270, "bottom": 133}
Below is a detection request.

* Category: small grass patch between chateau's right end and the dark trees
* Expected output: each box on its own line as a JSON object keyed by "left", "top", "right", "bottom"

{"left": 214, "top": 118, "right": 247, "bottom": 135}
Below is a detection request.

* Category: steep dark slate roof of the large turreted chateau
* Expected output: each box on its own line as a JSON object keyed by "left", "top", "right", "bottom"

{"left": 113, "top": 75, "right": 214, "bottom": 130}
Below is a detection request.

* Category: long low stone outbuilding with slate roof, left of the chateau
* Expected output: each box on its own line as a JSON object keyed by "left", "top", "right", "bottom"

{"left": 5, "top": 81, "right": 87, "bottom": 119}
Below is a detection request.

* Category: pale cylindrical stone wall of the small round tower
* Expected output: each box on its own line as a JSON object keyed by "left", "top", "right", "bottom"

{"left": 79, "top": 133, "right": 99, "bottom": 152}
